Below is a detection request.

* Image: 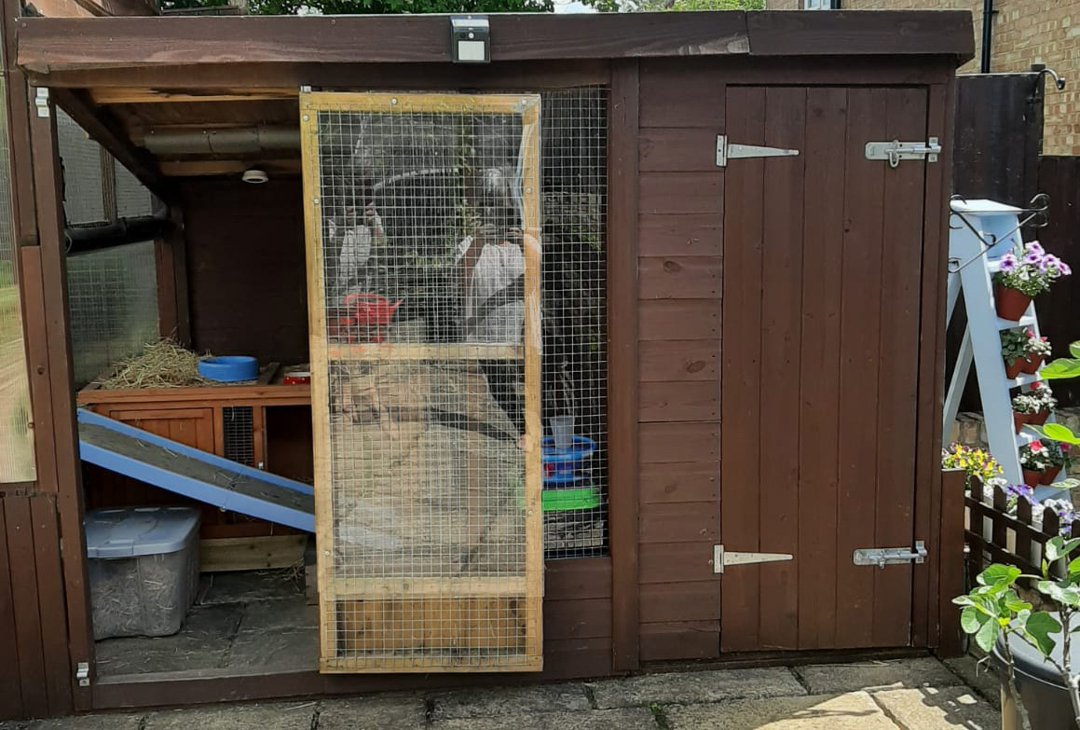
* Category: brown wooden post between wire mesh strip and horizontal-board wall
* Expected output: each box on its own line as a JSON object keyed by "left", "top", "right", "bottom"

{"left": 607, "top": 60, "right": 640, "bottom": 672}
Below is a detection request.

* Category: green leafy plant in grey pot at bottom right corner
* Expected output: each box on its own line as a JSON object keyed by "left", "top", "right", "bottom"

{"left": 953, "top": 537, "right": 1080, "bottom": 730}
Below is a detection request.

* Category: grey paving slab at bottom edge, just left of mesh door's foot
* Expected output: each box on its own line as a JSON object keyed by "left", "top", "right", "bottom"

{"left": 142, "top": 702, "right": 318, "bottom": 730}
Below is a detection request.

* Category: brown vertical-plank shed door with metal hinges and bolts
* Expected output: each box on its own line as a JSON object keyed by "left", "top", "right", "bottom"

{"left": 720, "top": 86, "right": 928, "bottom": 651}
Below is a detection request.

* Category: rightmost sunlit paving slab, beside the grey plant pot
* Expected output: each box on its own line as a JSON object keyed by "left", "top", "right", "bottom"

{"left": 874, "top": 687, "right": 1001, "bottom": 730}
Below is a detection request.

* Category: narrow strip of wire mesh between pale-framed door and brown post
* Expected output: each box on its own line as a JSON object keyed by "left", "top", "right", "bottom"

{"left": 541, "top": 86, "right": 608, "bottom": 558}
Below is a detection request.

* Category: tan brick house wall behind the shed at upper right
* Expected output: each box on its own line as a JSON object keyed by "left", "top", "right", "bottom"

{"left": 766, "top": 0, "right": 1080, "bottom": 157}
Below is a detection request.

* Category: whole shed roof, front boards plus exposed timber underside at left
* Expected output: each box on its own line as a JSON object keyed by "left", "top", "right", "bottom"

{"left": 16, "top": 11, "right": 974, "bottom": 187}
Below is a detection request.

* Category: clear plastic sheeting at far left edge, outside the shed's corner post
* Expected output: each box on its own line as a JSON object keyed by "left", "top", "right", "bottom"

{"left": 0, "top": 77, "right": 37, "bottom": 483}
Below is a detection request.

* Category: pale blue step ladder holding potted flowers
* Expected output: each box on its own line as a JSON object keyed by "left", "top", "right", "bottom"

{"left": 943, "top": 200, "right": 1064, "bottom": 499}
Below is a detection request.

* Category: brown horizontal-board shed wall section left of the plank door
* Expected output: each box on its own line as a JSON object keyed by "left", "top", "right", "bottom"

{"left": 638, "top": 56, "right": 725, "bottom": 661}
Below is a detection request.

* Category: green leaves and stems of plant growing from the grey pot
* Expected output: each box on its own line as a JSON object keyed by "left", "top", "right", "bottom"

{"left": 953, "top": 537, "right": 1080, "bottom": 730}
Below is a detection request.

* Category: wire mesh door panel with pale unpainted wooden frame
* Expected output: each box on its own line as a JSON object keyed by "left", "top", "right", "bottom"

{"left": 300, "top": 93, "right": 543, "bottom": 672}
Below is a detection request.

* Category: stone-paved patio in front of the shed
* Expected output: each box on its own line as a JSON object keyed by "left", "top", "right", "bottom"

{"left": 0, "top": 658, "right": 1000, "bottom": 730}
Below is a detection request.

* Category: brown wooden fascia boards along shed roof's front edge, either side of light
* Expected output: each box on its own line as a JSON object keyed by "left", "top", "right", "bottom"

{"left": 18, "top": 11, "right": 974, "bottom": 76}
